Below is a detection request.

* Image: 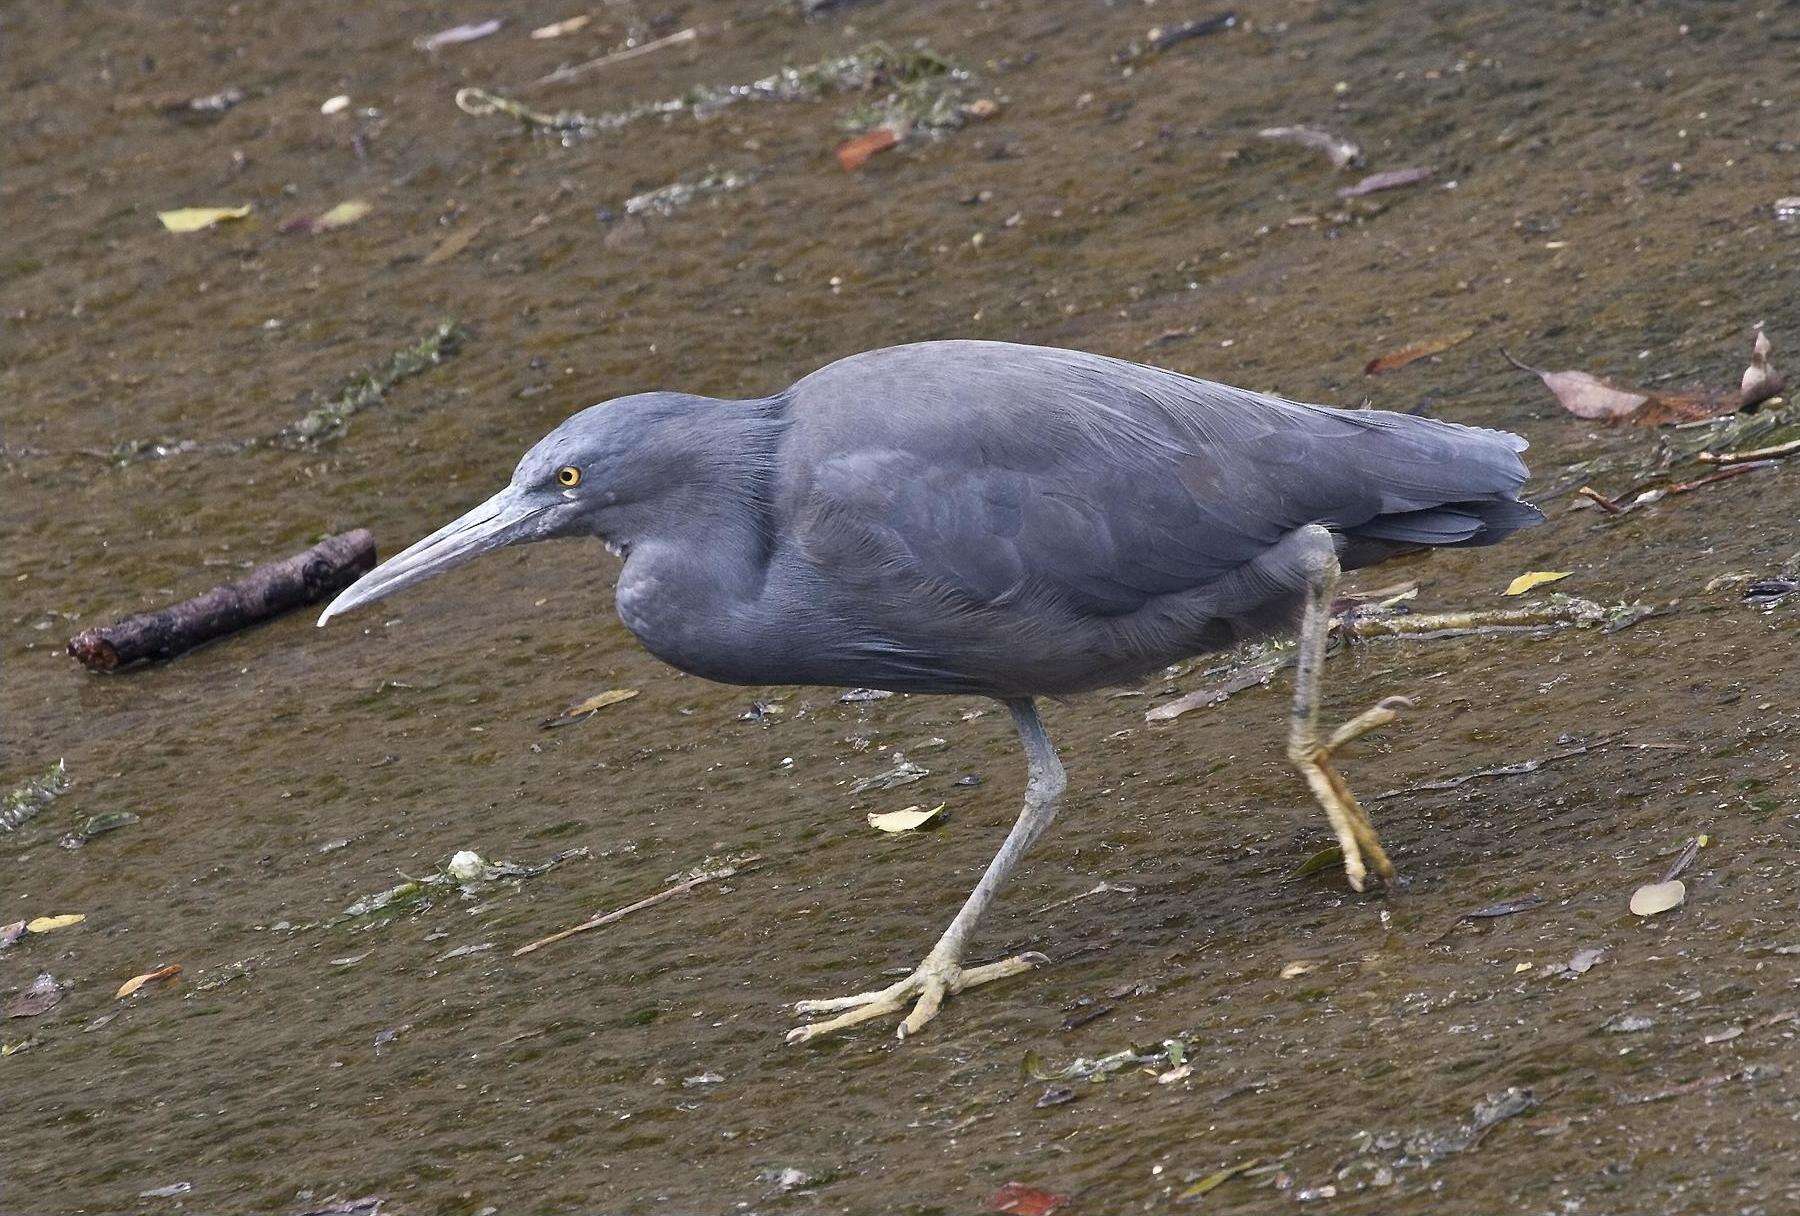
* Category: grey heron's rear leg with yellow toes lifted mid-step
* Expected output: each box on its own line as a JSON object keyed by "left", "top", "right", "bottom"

{"left": 1287, "top": 529, "right": 1413, "bottom": 890}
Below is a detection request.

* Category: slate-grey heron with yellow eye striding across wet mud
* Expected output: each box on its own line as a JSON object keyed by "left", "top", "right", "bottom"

{"left": 319, "top": 342, "right": 1543, "bottom": 1042}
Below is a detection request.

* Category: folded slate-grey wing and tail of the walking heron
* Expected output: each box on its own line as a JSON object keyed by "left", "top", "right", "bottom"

{"left": 783, "top": 342, "right": 1535, "bottom": 615}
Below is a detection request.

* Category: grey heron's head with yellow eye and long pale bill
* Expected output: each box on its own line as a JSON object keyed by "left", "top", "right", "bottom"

{"left": 319, "top": 392, "right": 700, "bottom": 624}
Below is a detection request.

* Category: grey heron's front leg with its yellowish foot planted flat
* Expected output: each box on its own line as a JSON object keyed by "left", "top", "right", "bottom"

{"left": 787, "top": 698, "right": 1067, "bottom": 1043}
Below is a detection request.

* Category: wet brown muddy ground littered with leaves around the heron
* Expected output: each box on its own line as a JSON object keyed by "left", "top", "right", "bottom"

{"left": 0, "top": 0, "right": 1800, "bottom": 1216}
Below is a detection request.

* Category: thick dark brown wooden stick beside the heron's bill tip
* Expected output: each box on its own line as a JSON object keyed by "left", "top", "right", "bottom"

{"left": 68, "top": 527, "right": 374, "bottom": 671}
